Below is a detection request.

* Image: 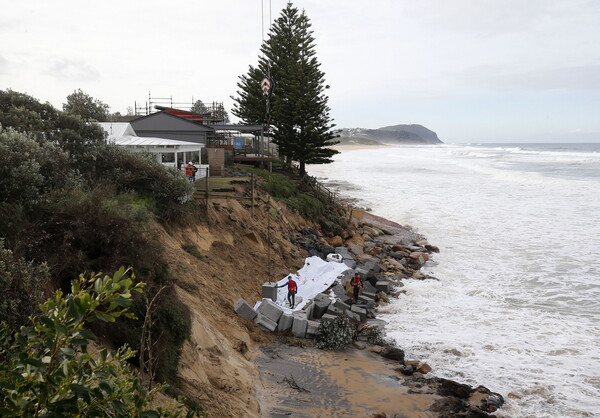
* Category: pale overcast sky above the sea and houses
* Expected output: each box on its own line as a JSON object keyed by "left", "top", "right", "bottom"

{"left": 0, "top": 0, "right": 600, "bottom": 143}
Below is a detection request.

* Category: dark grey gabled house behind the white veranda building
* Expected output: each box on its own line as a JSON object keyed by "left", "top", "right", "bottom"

{"left": 131, "top": 111, "right": 215, "bottom": 145}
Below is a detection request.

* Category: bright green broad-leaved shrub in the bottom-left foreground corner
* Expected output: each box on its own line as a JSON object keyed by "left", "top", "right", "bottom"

{"left": 0, "top": 268, "right": 191, "bottom": 417}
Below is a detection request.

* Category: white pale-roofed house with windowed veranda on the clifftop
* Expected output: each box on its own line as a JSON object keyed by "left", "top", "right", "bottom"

{"left": 100, "top": 122, "right": 204, "bottom": 167}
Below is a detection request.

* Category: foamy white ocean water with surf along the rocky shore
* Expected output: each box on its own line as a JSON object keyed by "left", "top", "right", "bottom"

{"left": 308, "top": 143, "right": 600, "bottom": 417}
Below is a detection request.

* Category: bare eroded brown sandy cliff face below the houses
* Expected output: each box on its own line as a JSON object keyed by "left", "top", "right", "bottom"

{"left": 157, "top": 191, "right": 322, "bottom": 417}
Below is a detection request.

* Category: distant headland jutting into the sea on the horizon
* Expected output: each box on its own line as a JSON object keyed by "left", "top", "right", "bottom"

{"left": 340, "top": 125, "right": 442, "bottom": 144}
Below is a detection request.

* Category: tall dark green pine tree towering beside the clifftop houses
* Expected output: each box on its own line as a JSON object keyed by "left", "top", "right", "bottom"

{"left": 232, "top": 3, "right": 338, "bottom": 175}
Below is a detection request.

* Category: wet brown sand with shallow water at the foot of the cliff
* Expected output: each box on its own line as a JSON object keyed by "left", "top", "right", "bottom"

{"left": 256, "top": 344, "right": 440, "bottom": 417}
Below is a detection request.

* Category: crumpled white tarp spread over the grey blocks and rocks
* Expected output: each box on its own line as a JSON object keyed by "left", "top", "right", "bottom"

{"left": 276, "top": 256, "right": 348, "bottom": 313}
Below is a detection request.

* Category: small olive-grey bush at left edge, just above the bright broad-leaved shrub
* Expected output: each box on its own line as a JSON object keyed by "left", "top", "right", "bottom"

{"left": 0, "top": 239, "right": 50, "bottom": 330}
